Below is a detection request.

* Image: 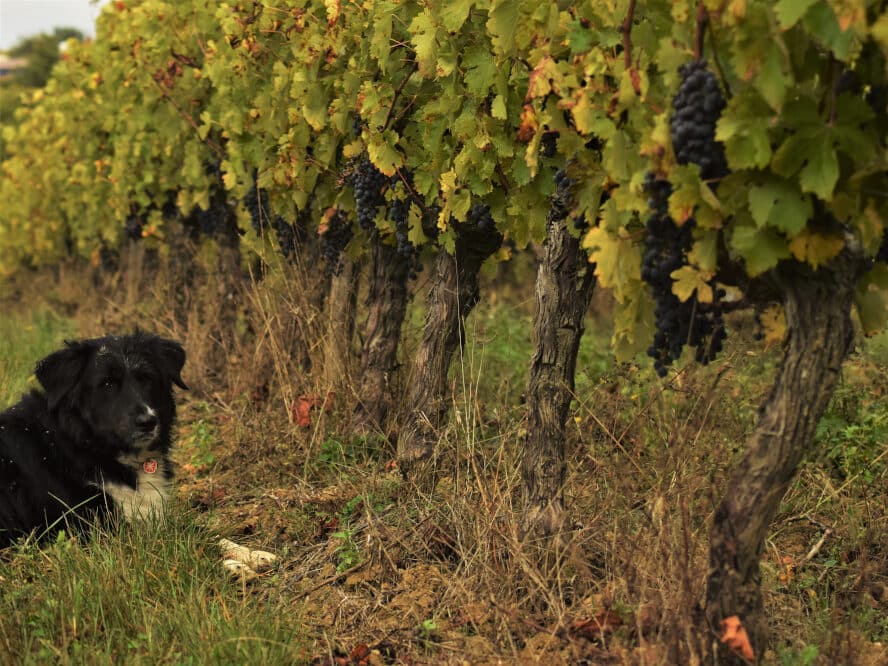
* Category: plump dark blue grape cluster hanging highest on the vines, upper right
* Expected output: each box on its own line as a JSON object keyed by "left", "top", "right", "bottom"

{"left": 669, "top": 60, "right": 728, "bottom": 180}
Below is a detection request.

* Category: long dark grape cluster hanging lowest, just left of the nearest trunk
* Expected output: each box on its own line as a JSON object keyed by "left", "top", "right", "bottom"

{"left": 641, "top": 173, "right": 727, "bottom": 377}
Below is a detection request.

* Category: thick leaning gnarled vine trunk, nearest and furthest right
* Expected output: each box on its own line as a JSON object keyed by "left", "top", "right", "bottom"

{"left": 706, "top": 251, "right": 859, "bottom": 663}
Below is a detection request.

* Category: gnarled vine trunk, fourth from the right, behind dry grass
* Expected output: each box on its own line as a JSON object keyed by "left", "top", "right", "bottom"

{"left": 351, "top": 240, "right": 410, "bottom": 434}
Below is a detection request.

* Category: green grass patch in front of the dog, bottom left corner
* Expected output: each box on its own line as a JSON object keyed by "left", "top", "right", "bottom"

{"left": 0, "top": 510, "right": 305, "bottom": 664}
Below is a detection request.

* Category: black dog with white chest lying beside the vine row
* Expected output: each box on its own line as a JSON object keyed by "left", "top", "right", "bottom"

{"left": 0, "top": 332, "right": 187, "bottom": 547}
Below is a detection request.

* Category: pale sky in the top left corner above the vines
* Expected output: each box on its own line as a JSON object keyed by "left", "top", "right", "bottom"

{"left": 0, "top": 0, "right": 107, "bottom": 50}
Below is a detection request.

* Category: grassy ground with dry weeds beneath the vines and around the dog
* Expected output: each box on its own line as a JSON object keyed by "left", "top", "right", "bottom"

{"left": 0, "top": 258, "right": 888, "bottom": 666}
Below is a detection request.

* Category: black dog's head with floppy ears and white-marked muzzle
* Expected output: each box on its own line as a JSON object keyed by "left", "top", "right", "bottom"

{"left": 36, "top": 332, "right": 188, "bottom": 450}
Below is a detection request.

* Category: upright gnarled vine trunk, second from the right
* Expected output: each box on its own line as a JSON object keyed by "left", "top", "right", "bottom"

{"left": 522, "top": 215, "right": 595, "bottom": 536}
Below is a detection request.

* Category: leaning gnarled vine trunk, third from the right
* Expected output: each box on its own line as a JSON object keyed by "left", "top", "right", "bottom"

{"left": 398, "top": 225, "right": 502, "bottom": 491}
